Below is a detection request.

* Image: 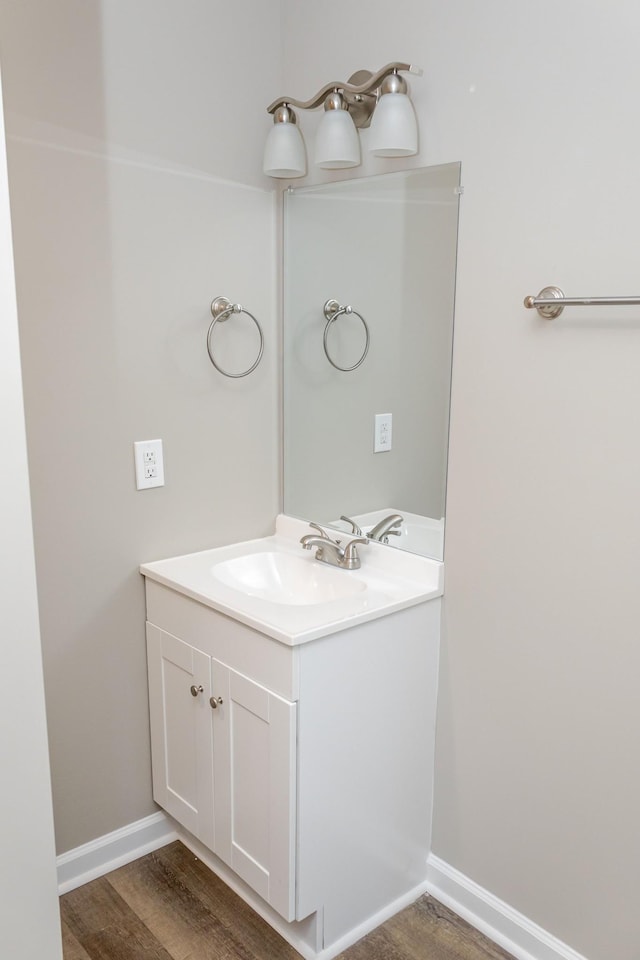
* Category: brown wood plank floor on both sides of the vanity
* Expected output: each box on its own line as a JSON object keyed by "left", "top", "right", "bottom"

{"left": 60, "top": 841, "right": 512, "bottom": 960}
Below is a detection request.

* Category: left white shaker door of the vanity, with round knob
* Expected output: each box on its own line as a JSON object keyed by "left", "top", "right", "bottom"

{"left": 147, "top": 623, "right": 214, "bottom": 849}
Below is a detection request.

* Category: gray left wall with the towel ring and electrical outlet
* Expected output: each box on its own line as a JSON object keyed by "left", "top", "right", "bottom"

{"left": 0, "top": 0, "right": 281, "bottom": 852}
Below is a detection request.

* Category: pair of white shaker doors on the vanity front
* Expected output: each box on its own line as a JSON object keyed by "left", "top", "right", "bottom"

{"left": 147, "top": 615, "right": 296, "bottom": 920}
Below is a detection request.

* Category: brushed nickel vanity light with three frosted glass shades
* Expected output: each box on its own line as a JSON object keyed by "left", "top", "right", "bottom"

{"left": 264, "top": 62, "right": 422, "bottom": 180}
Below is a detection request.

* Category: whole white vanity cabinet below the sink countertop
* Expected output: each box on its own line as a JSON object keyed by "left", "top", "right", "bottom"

{"left": 146, "top": 577, "right": 440, "bottom": 957}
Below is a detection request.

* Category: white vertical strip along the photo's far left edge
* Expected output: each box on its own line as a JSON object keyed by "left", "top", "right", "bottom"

{"left": 0, "top": 65, "right": 62, "bottom": 960}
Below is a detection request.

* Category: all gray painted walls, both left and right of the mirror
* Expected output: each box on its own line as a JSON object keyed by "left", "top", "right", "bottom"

{"left": 0, "top": 0, "right": 640, "bottom": 960}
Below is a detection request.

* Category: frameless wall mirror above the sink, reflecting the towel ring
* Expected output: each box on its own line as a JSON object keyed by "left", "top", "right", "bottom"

{"left": 284, "top": 163, "right": 460, "bottom": 559}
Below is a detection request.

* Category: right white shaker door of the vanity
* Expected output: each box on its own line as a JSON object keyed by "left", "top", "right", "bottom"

{"left": 211, "top": 660, "right": 296, "bottom": 920}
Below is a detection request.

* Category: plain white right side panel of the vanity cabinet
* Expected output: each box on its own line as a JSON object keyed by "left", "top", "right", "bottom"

{"left": 297, "top": 600, "right": 440, "bottom": 946}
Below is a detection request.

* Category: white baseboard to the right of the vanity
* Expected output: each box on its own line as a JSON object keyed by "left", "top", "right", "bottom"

{"left": 427, "top": 854, "right": 586, "bottom": 960}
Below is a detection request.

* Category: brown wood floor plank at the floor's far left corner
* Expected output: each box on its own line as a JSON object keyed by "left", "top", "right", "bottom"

{"left": 60, "top": 877, "right": 175, "bottom": 960}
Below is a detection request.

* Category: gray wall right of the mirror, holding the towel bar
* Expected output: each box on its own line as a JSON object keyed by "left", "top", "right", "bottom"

{"left": 285, "top": 0, "right": 640, "bottom": 960}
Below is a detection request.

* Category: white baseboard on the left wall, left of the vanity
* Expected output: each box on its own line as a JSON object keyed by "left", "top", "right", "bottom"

{"left": 56, "top": 811, "right": 178, "bottom": 894}
